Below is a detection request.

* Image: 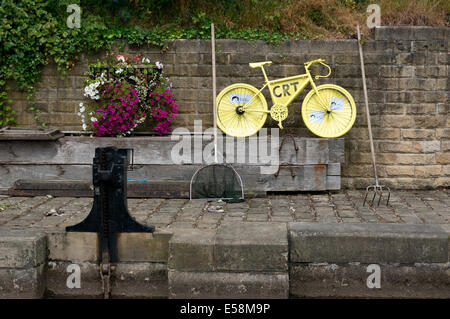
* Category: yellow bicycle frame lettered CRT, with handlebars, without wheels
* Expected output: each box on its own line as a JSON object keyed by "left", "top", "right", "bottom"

{"left": 242, "top": 63, "right": 331, "bottom": 113}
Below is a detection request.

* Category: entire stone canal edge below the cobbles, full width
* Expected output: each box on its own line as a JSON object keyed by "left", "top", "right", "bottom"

{"left": 0, "top": 222, "right": 450, "bottom": 299}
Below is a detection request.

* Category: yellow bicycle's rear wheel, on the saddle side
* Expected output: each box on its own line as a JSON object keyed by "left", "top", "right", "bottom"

{"left": 216, "top": 83, "right": 268, "bottom": 137}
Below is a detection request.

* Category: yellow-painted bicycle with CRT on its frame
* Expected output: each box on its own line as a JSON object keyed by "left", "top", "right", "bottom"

{"left": 216, "top": 59, "right": 356, "bottom": 137}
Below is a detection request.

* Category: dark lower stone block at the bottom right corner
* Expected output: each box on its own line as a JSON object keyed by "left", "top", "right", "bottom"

{"left": 289, "top": 263, "right": 450, "bottom": 298}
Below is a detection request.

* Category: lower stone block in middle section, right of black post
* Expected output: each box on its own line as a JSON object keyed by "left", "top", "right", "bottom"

{"left": 168, "top": 270, "right": 289, "bottom": 299}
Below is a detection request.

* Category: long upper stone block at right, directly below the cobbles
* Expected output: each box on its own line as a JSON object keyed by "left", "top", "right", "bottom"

{"left": 289, "top": 223, "right": 448, "bottom": 263}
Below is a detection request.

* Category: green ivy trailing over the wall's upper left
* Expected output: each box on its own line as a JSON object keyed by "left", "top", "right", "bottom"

{"left": 0, "top": 0, "right": 306, "bottom": 127}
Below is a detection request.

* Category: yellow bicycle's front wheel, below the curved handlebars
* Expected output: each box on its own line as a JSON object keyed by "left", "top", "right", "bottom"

{"left": 302, "top": 84, "right": 356, "bottom": 138}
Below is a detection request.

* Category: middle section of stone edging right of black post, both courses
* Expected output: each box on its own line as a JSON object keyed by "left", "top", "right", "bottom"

{"left": 168, "top": 222, "right": 289, "bottom": 299}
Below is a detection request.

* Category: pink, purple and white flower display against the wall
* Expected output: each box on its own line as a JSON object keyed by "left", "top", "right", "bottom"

{"left": 78, "top": 53, "right": 178, "bottom": 136}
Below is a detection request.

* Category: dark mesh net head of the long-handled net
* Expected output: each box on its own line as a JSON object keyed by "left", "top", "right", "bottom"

{"left": 190, "top": 164, "right": 244, "bottom": 203}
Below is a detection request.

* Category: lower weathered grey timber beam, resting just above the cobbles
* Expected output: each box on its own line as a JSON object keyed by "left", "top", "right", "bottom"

{"left": 0, "top": 165, "right": 334, "bottom": 192}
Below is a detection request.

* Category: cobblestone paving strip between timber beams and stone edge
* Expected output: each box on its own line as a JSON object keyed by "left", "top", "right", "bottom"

{"left": 0, "top": 189, "right": 450, "bottom": 230}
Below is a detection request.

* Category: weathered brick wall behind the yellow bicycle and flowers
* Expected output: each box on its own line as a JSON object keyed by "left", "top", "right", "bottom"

{"left": 10, "top": 27, "right": 450, "bottom": 189}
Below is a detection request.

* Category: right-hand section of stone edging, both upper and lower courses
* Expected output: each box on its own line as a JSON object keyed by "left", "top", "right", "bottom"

{"left": 289, "top": 223, "right": 450, "bottom": 298}
